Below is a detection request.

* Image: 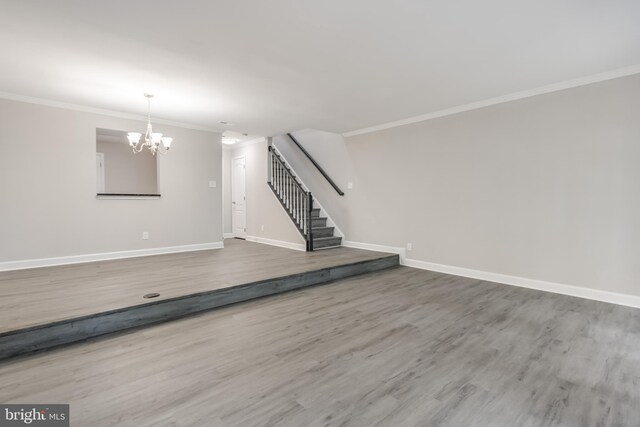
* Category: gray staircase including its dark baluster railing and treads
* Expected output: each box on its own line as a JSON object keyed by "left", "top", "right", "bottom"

{"left": 267, "top": 146, "right": 342, "bottom": 251}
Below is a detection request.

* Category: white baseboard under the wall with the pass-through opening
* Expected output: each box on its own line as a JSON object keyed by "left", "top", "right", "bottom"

{"left": 0, "top": 242, "right": 224, "bottom": 271}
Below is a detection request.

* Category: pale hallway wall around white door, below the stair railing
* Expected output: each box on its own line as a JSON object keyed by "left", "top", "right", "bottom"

{"left": 224, "top": 138, "right": 304, "bottom": 248}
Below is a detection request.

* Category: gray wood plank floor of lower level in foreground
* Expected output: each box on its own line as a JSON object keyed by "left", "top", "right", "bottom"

{"left": 0, "top": 267, "right": 640, "bottom": 427}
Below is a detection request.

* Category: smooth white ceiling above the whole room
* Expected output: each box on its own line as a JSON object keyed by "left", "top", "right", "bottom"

{"left": 0, "top": 0, "right": 640, "bottom": 135}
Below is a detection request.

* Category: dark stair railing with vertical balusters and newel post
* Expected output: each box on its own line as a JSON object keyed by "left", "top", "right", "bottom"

{"left": 267, "top": 145, "right": 313, "bottom": 252}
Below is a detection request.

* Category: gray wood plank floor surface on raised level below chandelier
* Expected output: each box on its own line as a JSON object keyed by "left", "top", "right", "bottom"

{"left": 0, "top": 239, "right": 388, "bottom": 333}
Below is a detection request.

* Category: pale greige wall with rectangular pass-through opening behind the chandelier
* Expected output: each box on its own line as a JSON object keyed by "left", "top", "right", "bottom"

{"left": 0, "top": 100, "right": 222, "bottom": 262}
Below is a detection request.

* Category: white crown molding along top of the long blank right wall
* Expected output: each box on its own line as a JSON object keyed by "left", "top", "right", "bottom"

{"left": 342, "top": 64, "right": 640, "bottom": 138}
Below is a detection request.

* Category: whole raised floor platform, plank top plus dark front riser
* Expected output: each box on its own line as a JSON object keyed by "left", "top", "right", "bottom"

{"left": 0, "top": 239, "right": 399, "bottom": 359}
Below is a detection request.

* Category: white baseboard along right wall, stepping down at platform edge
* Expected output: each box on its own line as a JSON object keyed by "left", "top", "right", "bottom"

{"left": 343, "top": 241, "right": 640, "bottom": 308}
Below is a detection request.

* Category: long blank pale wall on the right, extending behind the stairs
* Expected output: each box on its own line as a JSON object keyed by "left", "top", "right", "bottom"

{"left": 277, "top": 75, "right": 640, "bottom": 296}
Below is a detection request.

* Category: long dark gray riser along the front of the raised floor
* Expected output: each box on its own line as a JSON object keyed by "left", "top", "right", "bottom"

{"left": 0, "top": 255, "right": 399, "bottom": 360}
